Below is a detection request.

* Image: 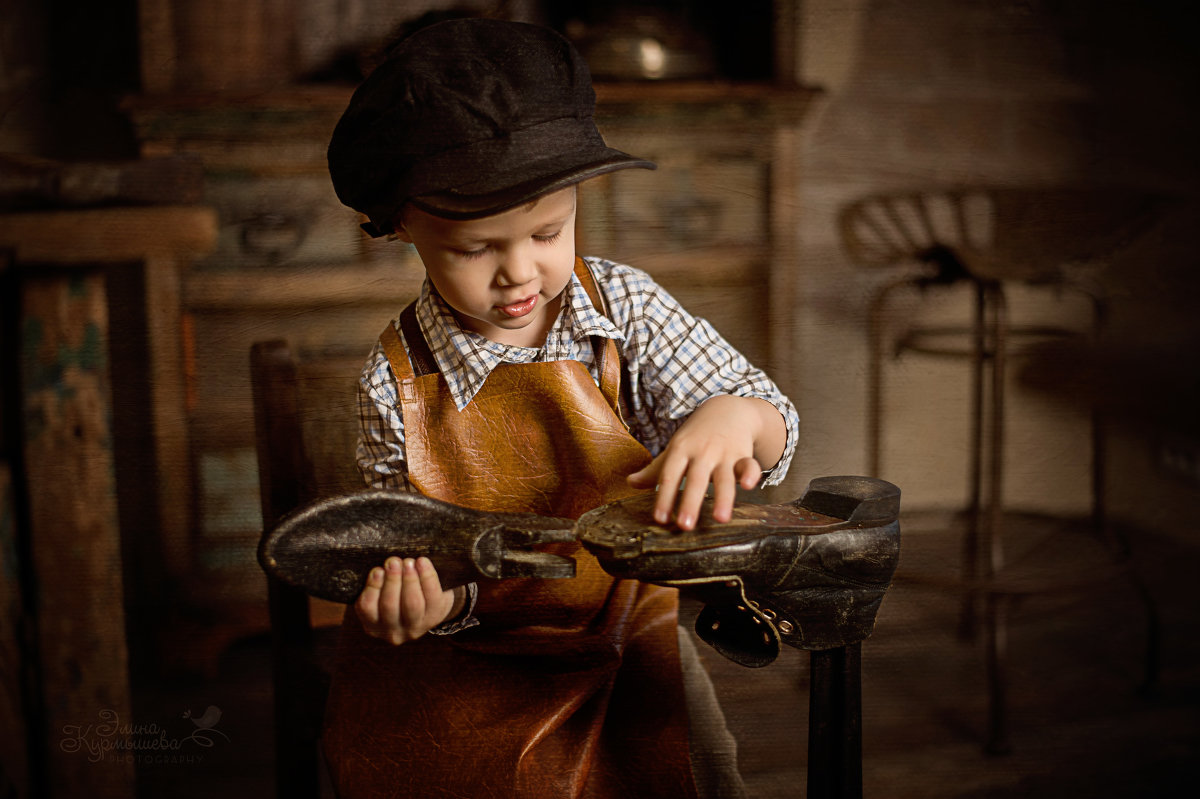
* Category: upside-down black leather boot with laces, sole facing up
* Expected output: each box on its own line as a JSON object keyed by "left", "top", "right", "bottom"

{"left": 577, "top": 476, "right": 900, "bottom": 666}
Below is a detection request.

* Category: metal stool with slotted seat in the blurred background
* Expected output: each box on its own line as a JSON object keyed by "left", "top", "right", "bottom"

{"left": 839, "top": 187, "right": 1159, "bottom": 753}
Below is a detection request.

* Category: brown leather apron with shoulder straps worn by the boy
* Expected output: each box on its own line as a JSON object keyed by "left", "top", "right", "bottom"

{"left": 324, "top": 260, "right": 695, "bottom": 799}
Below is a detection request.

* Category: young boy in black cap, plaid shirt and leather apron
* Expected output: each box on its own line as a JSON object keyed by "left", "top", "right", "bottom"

{"left": 324, "top": 14, "right": 797, "bottom": 799}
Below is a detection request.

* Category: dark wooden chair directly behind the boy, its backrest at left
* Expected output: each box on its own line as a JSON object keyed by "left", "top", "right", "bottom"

{"left": 251, "top": 341, "right": 365, "bottom": 799}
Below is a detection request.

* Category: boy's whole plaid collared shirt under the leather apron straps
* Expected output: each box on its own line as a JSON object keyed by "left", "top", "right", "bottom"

{"left": 358, "top": 258, "right": 799, "bottom": 491}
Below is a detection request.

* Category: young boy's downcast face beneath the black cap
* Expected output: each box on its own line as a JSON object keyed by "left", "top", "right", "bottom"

{"left": 396, "top": 186, "right": 575, "bottom": 347}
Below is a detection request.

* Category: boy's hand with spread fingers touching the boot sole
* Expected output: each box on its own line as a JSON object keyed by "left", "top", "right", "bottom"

{"left": 629, "top": 395, "right": 787, "bottom": 530}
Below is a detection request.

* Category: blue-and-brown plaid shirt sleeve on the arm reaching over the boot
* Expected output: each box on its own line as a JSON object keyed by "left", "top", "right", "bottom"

{"left": 598, "top": 262, "right": 799, "bottom": 486}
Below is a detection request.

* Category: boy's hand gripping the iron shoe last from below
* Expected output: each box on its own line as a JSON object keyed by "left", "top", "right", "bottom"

{"left": 354, "top": 558, "right": 458, "bottom": 644}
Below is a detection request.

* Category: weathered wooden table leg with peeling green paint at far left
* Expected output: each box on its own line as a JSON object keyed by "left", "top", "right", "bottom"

{"left": 20, "top": 272, "right": 134, "bottom": 798}
